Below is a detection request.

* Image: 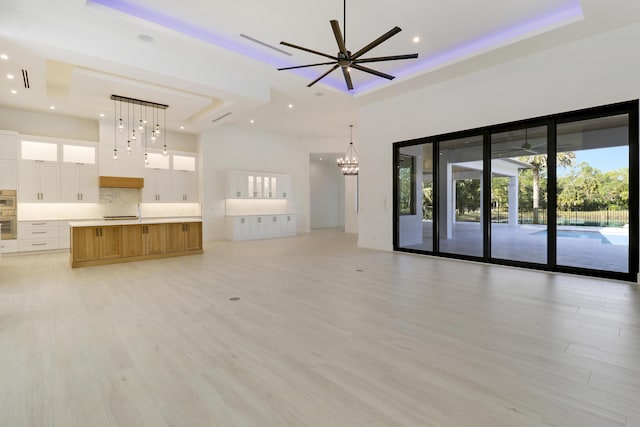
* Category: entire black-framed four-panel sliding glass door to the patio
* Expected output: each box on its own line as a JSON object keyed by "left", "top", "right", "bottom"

{"left": 394, "top": 101, "right": 639, "bottom": 280}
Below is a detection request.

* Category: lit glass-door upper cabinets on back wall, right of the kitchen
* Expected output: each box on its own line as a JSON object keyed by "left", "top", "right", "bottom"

{"left": 227, "top": 171, "right": 291, "bottom": 199}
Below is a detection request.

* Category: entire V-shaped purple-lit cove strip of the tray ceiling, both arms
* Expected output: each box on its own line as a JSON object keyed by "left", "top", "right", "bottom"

{"left": 87, "top": 0, "right": 584, "bottom": 95}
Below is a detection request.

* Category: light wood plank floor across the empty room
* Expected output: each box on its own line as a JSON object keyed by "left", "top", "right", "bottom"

{"left": 0, "top": 231, "right": 640, "bottom": 427}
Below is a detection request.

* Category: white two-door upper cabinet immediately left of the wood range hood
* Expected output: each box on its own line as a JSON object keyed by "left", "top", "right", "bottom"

{"left": 60, "top": 163, "right": 100, "bottom": 203}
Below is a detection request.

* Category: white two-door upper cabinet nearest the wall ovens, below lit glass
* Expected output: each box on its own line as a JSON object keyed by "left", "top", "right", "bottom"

{"left": 18, "top": 160, "right": 60, "bottom": 202}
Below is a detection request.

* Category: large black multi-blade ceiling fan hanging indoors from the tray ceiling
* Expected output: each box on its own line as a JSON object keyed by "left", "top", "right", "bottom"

{"left": 278, "top": 0, "right": 418, "bottom": 90}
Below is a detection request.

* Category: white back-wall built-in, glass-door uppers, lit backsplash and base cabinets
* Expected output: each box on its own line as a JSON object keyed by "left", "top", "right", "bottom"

{"left": 225, "top": 171, "right": 296, "bottom": 244}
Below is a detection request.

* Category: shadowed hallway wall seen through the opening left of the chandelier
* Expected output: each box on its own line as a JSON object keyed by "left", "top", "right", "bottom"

{"left": 309, "top": 154, "right": 345, "bottom": 229}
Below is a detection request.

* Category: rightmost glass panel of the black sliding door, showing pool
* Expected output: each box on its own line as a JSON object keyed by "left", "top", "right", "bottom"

{"left": 556, "top": 114, "right": 630, "bottom": 273}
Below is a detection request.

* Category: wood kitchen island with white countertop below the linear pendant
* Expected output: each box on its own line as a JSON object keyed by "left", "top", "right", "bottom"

{"left": 69, "top": 218, "right": 203, "bottom": 268}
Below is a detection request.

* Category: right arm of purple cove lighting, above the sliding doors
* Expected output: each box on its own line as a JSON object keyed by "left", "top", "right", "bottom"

{"left": 351, "top": 0, "right": 584, "bottom": 95}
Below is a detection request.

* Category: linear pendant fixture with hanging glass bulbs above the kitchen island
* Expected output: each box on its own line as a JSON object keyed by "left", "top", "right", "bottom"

{"left": 111, "top": 95, "right": 169, "bottom": 164}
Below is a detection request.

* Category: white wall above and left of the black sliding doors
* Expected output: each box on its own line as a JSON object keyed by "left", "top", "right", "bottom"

{"left": 358, "top": 24, "right": 640, "bottom": 250}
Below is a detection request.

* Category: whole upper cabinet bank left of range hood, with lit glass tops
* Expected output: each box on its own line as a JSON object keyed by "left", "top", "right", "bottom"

{"left": 18, "top": 138, "right": 99, "bottom": 203}
